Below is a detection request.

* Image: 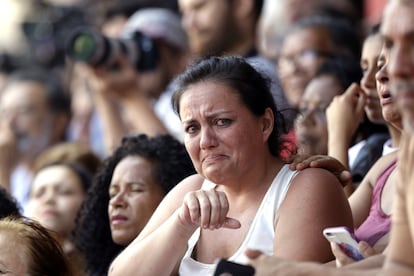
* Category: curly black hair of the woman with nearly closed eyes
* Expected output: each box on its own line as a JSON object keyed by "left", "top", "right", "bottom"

{"left": 73, "top": 134, "right": 195, "bottom": 275}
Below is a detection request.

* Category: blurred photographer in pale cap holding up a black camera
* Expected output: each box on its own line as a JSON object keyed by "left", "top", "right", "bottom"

{"left": 67, "top": 8, "right": 190, "bottom": 154}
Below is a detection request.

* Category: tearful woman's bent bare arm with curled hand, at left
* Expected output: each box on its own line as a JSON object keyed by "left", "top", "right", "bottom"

{"left": 109, "top": 175, "right": 240, "bottom": 276}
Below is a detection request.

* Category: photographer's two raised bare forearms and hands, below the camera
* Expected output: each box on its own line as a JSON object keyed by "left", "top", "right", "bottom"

{"left": 85, "top": 58, "right": 168, "bottom": 152}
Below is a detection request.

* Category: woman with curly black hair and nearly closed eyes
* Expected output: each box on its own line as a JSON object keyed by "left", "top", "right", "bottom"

{"left": 74, "top": 134, "right": 195, "bottom": 275}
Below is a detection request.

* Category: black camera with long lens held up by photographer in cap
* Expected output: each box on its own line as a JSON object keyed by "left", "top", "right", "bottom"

{"left": 65, "top": 27, "right": 160, "bottom": 72}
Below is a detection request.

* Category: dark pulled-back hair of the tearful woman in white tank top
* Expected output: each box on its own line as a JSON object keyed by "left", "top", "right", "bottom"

{"left": 172, "top": 56, "right": 287, "bottom": 157}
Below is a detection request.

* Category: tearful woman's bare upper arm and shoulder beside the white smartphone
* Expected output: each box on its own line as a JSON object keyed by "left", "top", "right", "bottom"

{"left": 274, "top": 168, "right": 353, "bottom": 262}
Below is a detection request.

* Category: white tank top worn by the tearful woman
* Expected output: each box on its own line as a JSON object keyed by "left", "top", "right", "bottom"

{"left": 179, "top": 165, "right": 297, "bottom": 276}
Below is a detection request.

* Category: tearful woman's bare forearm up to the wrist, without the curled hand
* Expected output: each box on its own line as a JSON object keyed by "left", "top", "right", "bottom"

{"left": 108, "top": 213, "right": 194, "bottom": 276}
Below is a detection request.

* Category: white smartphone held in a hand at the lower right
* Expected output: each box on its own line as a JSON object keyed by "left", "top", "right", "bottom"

{"left": 323, "top": 226, "right": 364, "bottom": 261}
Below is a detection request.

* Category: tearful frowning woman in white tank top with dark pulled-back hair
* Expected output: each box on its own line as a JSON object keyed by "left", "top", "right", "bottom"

{"left": 109, "top": 57, "right": 352, "bottom": 275}
